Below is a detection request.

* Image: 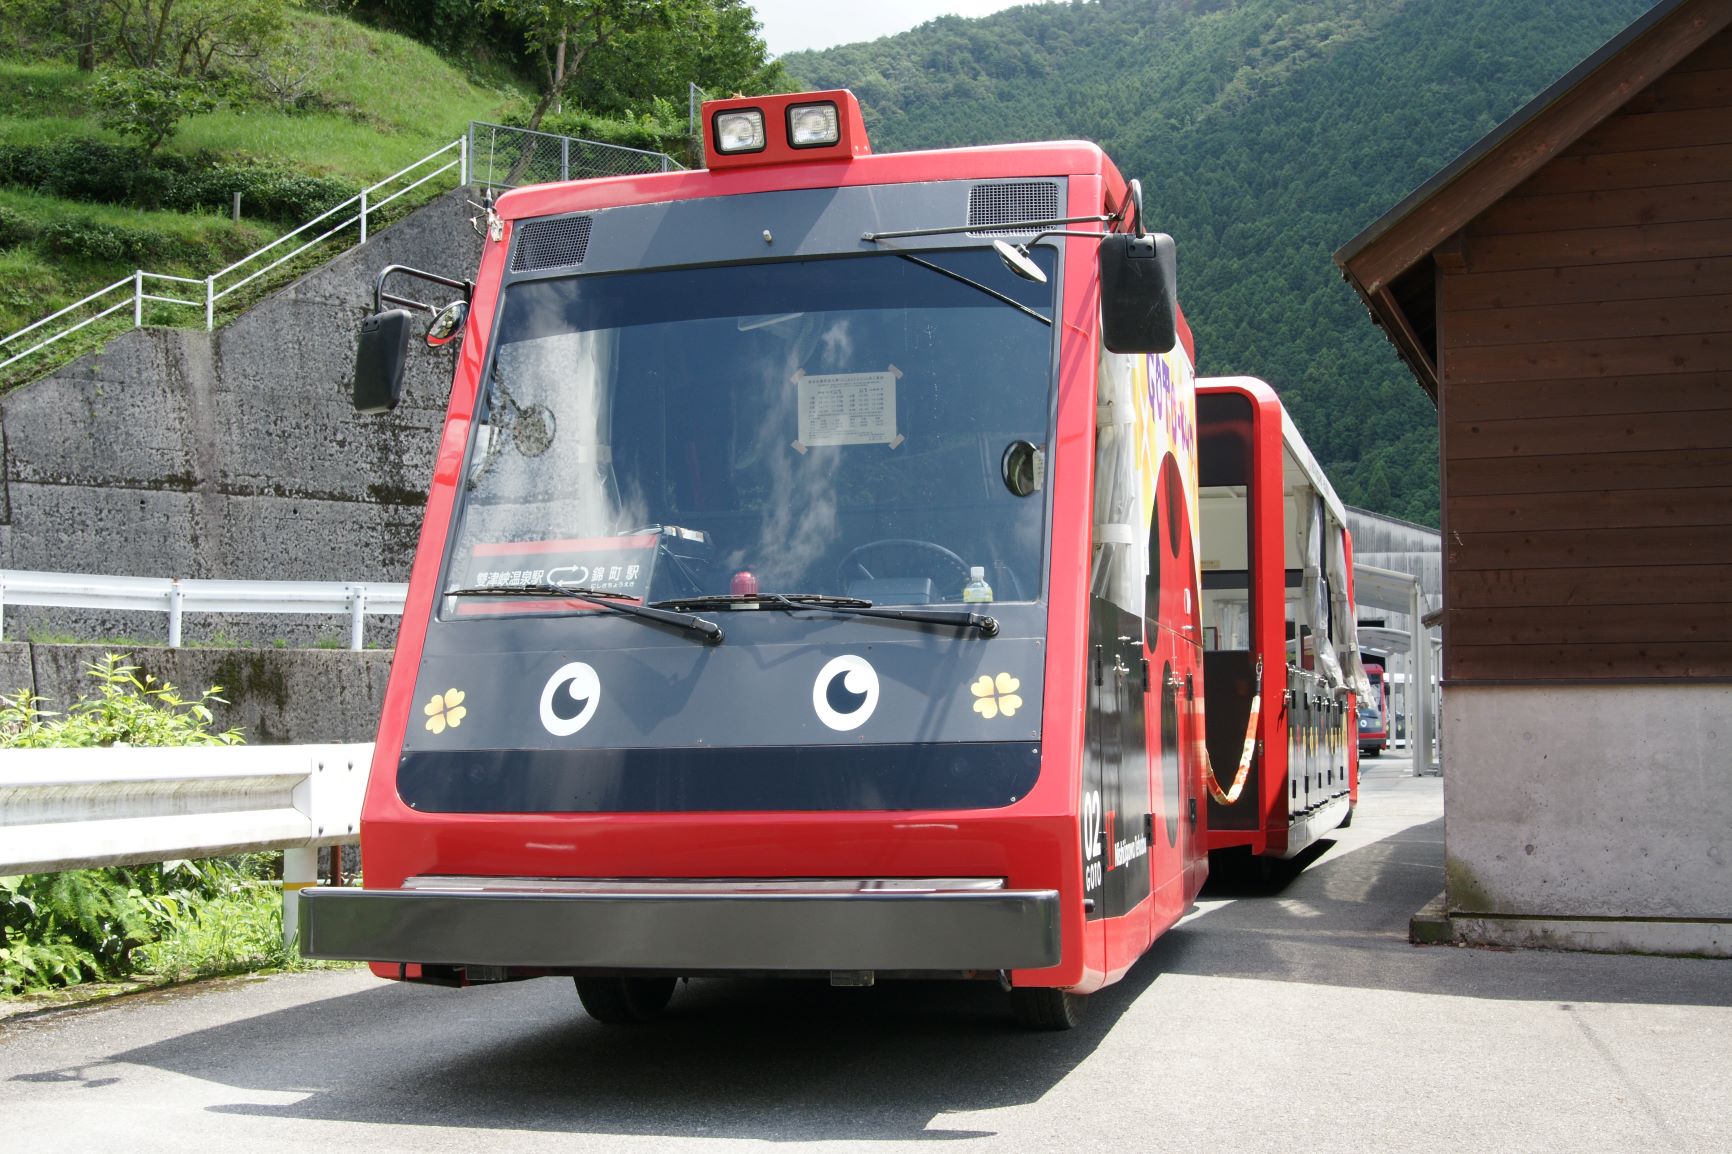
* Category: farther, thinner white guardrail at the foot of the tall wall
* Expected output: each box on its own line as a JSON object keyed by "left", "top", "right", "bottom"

{"left": 0, "top": 568, "right": 409, "bottom": 650}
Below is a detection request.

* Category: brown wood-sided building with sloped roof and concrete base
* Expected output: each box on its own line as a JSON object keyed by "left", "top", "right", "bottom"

{"left": 1335, "top": 0, "right": 1732, "bottom": 953}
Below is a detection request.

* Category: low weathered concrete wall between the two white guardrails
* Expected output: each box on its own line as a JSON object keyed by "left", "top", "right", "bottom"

{"left": 0, "top": 643, "right": 391, "bottom": 745}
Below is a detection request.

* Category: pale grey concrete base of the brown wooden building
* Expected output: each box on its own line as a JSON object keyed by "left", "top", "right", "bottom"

{"left": 1443, "top": 684, "right": 1732, "bottom": 953}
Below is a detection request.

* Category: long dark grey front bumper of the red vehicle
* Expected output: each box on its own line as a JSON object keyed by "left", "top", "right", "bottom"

{"left": 300, "top": 878, "right": 1060, "bottom": 972}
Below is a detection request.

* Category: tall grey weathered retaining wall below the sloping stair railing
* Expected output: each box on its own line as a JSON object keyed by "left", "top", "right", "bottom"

{"left": 0, "top": 191, "right": 480, "bottom": 645}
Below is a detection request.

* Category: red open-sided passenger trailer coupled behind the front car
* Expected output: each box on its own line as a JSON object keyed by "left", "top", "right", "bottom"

{"left": 1186, "top": 376, "right": 1367, "bottom": 863}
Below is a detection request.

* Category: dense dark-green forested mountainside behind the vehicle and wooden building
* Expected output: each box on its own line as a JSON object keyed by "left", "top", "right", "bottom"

{"left": 781, "top": 0, "right": 1651, "bottom": 525}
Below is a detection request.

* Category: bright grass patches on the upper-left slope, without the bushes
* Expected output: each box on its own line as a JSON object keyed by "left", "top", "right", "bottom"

{"left": 0, "top": 12, "right": 525, "bottom": 392}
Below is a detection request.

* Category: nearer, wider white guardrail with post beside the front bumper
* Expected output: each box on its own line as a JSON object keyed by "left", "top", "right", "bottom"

{"left": 0, "top": 743, "right": 372, "bottom": 946}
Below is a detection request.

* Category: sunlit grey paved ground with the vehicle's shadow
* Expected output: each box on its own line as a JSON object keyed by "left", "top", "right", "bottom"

{"left": 0, "top": 757, "right": 1732, "bottom": 1154}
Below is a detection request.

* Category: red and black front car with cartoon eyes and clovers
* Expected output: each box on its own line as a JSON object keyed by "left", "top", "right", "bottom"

{"left": 303, "top": 92, "right": 1202, "bottom": 1028}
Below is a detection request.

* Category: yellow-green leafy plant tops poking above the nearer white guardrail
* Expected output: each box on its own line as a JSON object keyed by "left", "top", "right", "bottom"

{"left": 0, "top": 653, "right": 241, "bottom": 749}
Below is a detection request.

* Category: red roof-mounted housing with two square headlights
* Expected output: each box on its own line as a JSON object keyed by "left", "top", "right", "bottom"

{"left": 703, "top": 88, "right": 871, "bottom": 170}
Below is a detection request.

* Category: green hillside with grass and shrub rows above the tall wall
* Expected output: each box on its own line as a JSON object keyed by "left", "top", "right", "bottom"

{"left": 0, "top": 7, "right": 527, "bottom": 388}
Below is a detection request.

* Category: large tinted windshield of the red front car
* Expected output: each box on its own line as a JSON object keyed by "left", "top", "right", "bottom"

{"left": 443, "top": 250, "right": 1053, "bottom": 613}
